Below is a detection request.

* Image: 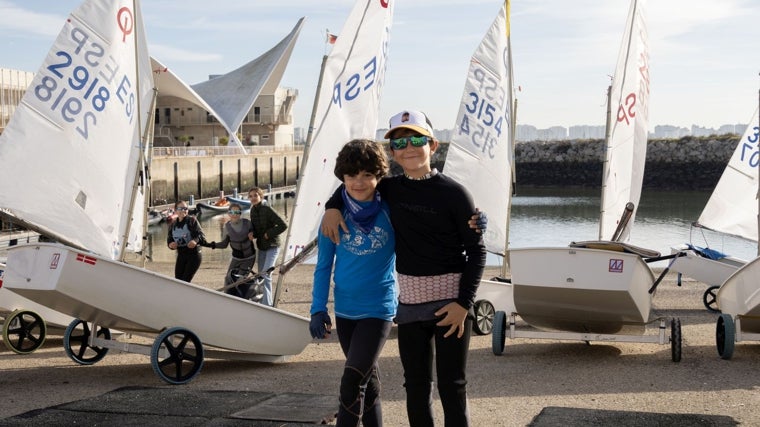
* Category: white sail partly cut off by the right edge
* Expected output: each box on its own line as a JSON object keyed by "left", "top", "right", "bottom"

{"left": 698, "top": 109, "right": 760, "bottom": 241}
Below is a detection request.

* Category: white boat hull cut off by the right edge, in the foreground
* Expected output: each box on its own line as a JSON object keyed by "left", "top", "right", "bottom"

{"left": 716, "top": 257, "right": 760, "bottom": 333}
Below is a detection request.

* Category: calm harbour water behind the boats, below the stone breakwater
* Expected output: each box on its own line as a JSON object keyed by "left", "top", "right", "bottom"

{"left": 148, "top": 188, "right": 757, "bottom": 267}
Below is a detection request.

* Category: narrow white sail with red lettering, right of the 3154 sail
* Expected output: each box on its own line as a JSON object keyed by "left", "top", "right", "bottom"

{"left": 599, "top": 0, "right": 649, "bottom": 242}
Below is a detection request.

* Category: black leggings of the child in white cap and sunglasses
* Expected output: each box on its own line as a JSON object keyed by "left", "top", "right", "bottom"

{"left": 398, "top": 316, "right": 472, "bottom": 427}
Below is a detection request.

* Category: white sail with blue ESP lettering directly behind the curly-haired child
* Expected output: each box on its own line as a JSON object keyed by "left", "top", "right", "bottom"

{"left": 285, "top": 0, "right": 393, "bottom": 259}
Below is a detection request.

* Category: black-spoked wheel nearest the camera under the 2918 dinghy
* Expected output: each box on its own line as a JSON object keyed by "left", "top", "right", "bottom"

{"left": 150, "top": 328, "right": 203, "bottom": 385}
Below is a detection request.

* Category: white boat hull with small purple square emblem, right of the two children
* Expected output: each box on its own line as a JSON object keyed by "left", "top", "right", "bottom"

{"left": 509, "top": 247, "right": 655, "bottom": 334}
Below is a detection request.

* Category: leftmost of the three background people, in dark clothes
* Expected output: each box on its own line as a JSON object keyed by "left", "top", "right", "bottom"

{"left": 166, "top": 200, "right": 205, "bottom": 282}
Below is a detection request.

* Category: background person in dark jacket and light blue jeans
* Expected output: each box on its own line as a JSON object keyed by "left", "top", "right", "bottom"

{"left": 248, "top": 187, "right": 288, "bottom": 305}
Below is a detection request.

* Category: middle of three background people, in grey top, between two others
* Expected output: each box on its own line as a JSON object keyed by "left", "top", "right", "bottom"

{"left": 208, "top": 203, "right": 256, "bottom": 299}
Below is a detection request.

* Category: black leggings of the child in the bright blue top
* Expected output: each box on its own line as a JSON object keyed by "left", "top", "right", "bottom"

{"left": 335, "top": 316, "right": 392, "bottom": 427}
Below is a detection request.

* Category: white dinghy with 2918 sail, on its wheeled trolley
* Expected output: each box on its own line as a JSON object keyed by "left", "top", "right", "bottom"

{"left": 0, "top": 0, "right": 311, "bottom": 384}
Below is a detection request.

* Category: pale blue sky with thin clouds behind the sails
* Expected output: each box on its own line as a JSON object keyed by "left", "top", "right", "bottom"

{"left": 0, "top": 0, "right": 760, "bottom": 130}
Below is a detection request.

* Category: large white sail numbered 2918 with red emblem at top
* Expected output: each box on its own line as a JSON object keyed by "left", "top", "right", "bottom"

{"left": 0, "top": 0, "right": 153, "bottom": 259}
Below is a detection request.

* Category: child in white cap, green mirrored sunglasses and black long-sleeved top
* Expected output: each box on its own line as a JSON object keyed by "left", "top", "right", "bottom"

{"left": 322, "top": 110, "right": 486, "bottom": 427}
